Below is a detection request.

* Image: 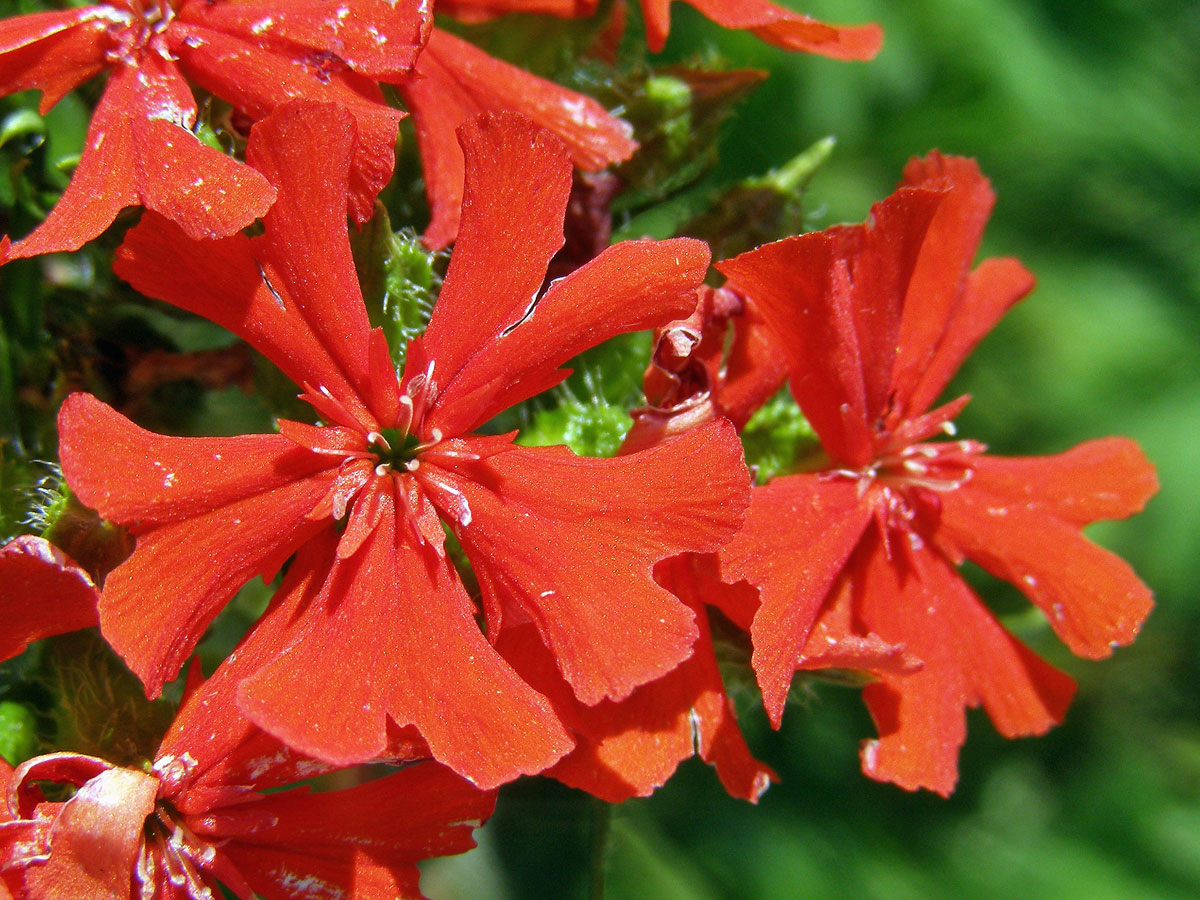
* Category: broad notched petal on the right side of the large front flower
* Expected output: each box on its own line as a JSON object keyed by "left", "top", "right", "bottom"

{"left": 418, "top": 420, "right": 749, "bottom": 704}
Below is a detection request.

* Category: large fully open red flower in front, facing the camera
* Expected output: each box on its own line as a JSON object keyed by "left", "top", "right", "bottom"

{"left": 59, "top": 106, "right": 749, "bottom": 786}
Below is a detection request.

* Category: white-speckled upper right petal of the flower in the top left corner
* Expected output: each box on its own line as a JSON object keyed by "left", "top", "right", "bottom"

{"left": 179, "top": 0, "right": 433, "bottom": 80}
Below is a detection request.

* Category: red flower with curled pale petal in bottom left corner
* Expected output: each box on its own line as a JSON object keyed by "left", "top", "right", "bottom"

{"left": 0, "top": 633, "right": 494, "bottom": 900}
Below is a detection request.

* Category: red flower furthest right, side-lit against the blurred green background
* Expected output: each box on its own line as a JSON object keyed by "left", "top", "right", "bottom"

{"left": 718, "top": 154, "right": 1157, "bottom": 793}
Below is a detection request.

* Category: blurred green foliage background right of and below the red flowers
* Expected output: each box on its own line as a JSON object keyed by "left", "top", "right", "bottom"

{"left": 427, "top": 0, "right": 1200, "bottom": 900}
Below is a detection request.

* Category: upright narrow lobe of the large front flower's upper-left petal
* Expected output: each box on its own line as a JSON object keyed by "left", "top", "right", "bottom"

{"left": 246, "top": 102, "right": 398, "bottom": 424}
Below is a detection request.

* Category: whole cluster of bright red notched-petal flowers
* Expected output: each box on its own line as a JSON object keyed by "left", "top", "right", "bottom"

{"left": 0, "top": 0, "right": 1157, "bottom": 900}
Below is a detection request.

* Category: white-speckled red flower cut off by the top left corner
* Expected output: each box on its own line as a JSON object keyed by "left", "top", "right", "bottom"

{"left": 0, "top": 0, "right": 432, "bottom": 262}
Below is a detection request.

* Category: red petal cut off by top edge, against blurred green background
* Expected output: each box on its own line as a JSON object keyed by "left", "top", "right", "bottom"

{"left": 676, "top": 0, "right": 883, "bottom": 60}
